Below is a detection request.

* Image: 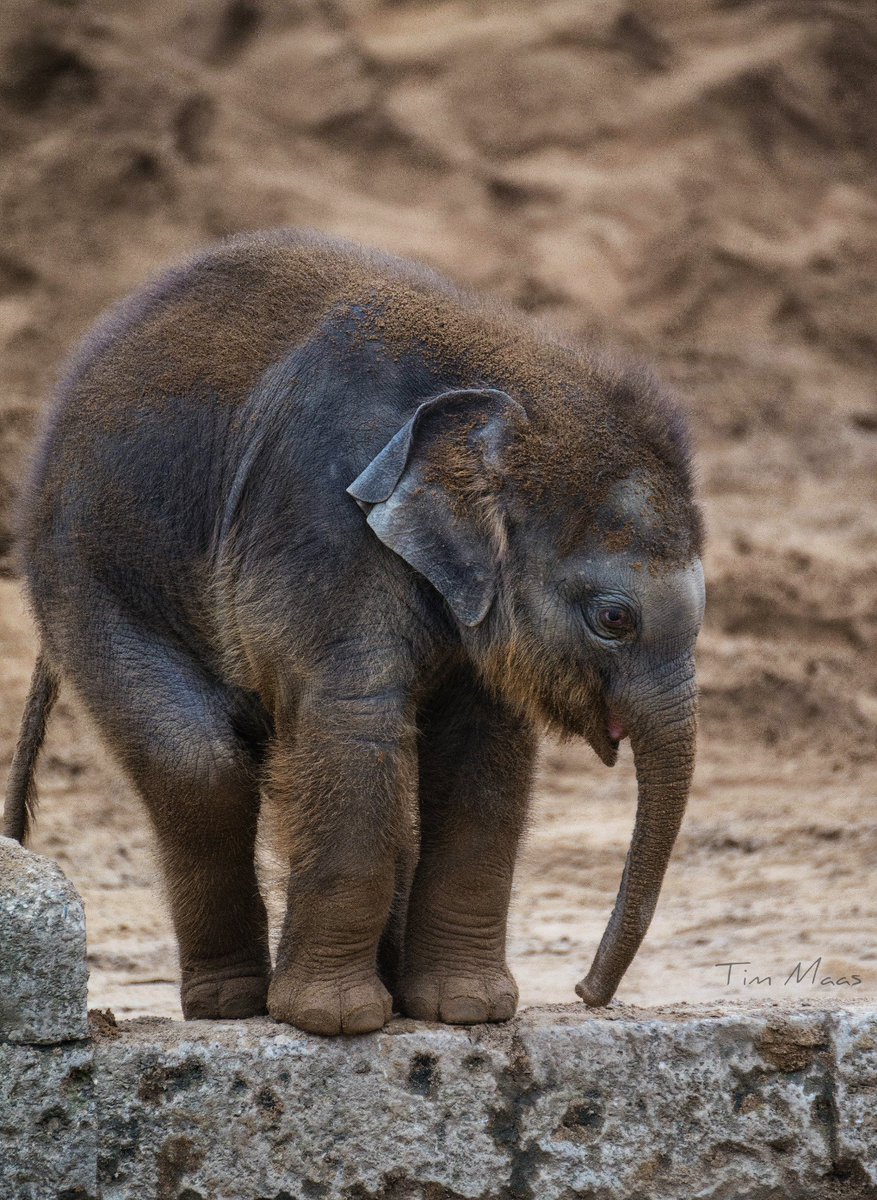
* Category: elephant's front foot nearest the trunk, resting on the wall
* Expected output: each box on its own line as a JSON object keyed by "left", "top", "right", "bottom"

{"left": 400, "top": 967, "right": 518, "bottom": 1025}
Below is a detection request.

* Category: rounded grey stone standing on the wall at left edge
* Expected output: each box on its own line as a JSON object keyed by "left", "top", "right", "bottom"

{"left": 0, "top": 838, "right": 88, "bottom": 1044}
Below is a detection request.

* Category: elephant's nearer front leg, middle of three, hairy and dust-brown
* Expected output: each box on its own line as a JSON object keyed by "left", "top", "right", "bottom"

{"left": 268, "top": 695, "right": 415, "bottom": 1034}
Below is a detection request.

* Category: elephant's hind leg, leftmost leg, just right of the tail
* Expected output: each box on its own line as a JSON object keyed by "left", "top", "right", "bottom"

{"left": 71, "top": 618, "right": 271, "bottom": 1018}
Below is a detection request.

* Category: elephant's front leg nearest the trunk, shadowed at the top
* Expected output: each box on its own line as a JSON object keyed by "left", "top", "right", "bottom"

{"left": 398, "top": 674, "right": 535, "bottom": 1025}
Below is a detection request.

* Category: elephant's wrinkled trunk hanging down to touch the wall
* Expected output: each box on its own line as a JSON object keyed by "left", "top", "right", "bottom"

{"left": 576, "top": 660, "right": 697, "bottom": 1007}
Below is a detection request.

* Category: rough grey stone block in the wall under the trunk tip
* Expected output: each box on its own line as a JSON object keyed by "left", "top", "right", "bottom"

{"left": 518, "top": 1010, "right": 839, "bottom": 1200}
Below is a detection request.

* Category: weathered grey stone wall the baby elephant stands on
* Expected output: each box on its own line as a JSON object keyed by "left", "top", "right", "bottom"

{"left": 0, "top": 841, "right": 877, "bottom": 1200}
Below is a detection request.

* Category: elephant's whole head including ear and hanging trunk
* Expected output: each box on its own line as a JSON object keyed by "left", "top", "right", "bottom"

{"left": 348, "top": 389, "right": 704, "bottom": 1004}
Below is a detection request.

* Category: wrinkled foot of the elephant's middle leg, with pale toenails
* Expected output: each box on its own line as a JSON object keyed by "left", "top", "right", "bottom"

{"left": 268, "top": 970, "right": 392, "bottom": 1037}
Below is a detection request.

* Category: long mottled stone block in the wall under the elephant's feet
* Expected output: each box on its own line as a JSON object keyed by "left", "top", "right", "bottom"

{"left": 96, "top": 1019, "right": 509, "bottom": 1200}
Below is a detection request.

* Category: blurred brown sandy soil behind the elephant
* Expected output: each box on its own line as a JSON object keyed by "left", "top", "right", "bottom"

{"left": 0, "top": 0, "right": 877, "bottom": 1015}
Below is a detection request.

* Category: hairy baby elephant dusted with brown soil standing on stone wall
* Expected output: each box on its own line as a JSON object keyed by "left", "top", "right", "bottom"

{"left": 6, "top": 232, "right": 703, "bottom": 1034}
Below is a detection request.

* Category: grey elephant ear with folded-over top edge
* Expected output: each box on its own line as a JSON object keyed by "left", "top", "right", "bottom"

{"left": 347, "top": 388, "right": 527, "bottom": 625}
